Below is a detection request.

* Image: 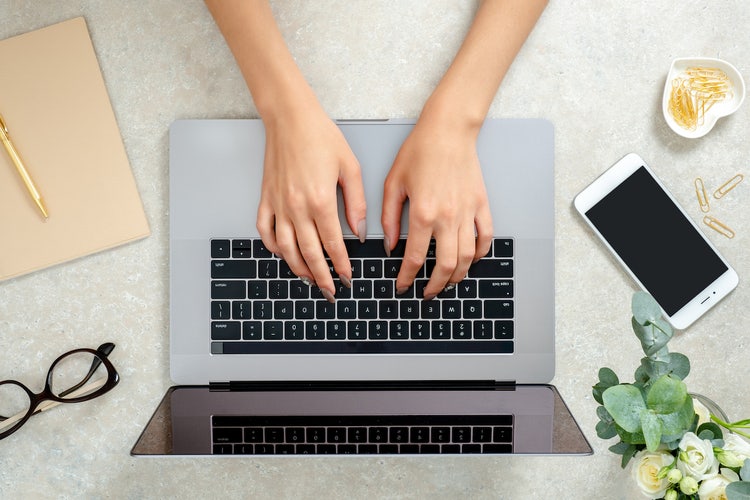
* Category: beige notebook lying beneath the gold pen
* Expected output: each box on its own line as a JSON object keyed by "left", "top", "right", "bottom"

{"left": 0, "top": 18, "right": 149, "bottom": 280}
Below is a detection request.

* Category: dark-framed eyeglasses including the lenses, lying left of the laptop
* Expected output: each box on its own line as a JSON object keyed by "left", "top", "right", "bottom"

{"left": 0, "top": 342, "right": 120, "bottom": 439}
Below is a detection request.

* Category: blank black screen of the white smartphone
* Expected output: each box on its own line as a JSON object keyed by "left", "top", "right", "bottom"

{"left": 586, "top": 167, "right": 728, "bottom": 316}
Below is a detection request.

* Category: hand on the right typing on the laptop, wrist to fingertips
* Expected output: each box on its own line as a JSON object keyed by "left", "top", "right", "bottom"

{"left": 381, "top": 118, "right": 492, "bottom": 300}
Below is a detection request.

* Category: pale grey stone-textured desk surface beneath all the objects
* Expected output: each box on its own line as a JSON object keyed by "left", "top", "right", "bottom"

{"left": 0, "top": 0, "right": 750, "bottom": 499}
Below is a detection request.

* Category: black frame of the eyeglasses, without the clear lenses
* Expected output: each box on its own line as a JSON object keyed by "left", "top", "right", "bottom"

{"left": 0, "top": 342, "right": 120, "bottom": 440}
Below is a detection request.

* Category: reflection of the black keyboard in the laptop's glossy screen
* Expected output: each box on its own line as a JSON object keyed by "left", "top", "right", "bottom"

{"left": 212, "top": 415, "right": 513, "bottom": 455}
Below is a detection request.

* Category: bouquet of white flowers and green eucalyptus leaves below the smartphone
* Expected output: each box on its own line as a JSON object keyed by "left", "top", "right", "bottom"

{"left": 593, "top": 292, "right": 750, "bottom": 500}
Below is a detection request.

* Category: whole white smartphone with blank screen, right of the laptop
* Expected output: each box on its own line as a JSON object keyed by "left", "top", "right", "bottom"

{"left": 574, "top": 153, "right": 738, "bottom": 330}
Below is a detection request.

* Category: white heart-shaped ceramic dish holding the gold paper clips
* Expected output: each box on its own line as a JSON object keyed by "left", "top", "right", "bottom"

{"left": 662, "top": 57, "right": 745, "bottom": 139}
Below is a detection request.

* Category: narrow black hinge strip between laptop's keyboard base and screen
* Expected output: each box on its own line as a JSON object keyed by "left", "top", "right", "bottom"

{"left": 209, "top": 380, "right": 516, "bottom": 391}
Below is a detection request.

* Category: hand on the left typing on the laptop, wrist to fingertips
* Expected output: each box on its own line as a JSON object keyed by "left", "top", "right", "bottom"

{"left": 257, "top": 110, "right": 366, "bottom": 301}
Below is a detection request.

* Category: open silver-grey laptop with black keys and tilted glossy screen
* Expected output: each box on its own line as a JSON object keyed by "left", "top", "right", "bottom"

{"left": 132, "top": 119, "right": 592, "bottom": 455}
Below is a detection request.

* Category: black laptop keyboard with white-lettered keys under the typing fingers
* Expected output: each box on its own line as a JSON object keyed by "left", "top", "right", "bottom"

{"left": 210, "top": 238, "right": 514, "bottom": 354}
